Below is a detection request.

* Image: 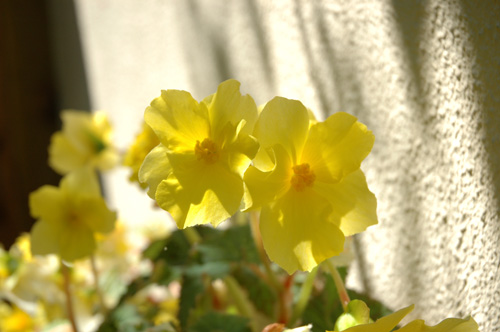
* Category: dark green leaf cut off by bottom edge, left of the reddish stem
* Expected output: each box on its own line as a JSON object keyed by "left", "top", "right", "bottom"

{"left": 188, "top": 312, "right": 251, "bottom": 332}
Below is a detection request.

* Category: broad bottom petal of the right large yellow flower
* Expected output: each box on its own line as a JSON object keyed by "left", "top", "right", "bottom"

{"left": 260, "top": 189, "right": 344, "bottom": 274}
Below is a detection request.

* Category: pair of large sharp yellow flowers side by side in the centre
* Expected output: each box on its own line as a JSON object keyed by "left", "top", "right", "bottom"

{"left": 139, "top": 80, "right": 377, "bottom": 273}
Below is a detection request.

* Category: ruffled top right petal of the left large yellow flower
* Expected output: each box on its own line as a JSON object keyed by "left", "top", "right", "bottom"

{"left": 204, "top": 79, "right": 258, "bottom": 142}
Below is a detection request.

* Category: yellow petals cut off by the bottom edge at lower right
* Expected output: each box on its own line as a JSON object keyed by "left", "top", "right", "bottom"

{"left": 327, "top": 305, "right": 479, "bottom": 332}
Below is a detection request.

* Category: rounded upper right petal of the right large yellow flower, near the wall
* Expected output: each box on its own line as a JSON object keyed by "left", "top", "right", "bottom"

{"left": 301, "top": 112, "right": 375, "bottom": 182}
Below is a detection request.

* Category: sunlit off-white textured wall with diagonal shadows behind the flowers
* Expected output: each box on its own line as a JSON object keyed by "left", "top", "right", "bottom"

{"left": 76, "top": 0, "right": 500, "bottom": 332}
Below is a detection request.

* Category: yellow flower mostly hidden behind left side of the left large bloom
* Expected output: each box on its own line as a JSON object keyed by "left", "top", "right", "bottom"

{"left": 123, "top": 123, "right": 160, "bottom": 189}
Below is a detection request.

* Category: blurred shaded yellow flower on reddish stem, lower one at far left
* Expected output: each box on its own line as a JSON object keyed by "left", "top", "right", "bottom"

{"left": 29, "top": 168, "right": 116, "bottom": 261}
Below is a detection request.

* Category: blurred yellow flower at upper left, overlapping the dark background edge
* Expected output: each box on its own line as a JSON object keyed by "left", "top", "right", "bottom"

{"left": 49, "top": 110, "right": 118, "bottom": 175}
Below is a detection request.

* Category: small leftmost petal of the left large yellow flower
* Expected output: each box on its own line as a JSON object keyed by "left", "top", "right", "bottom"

{"left": 139, "top": 144, "right": 172, "bottom": 199}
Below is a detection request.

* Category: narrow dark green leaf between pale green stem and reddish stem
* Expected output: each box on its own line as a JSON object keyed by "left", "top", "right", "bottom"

{"left": 233, "top": 266, "right": 277, "bottom": 317}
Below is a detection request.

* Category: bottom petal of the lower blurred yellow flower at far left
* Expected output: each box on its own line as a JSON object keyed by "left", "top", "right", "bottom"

{"left": 59, "top": 223, "right": 96, "bottom": 261}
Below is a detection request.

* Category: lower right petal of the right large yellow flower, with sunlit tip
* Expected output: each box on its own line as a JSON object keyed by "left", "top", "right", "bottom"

{"left": 314, "top": 170, "right": 377, "bottom": 236}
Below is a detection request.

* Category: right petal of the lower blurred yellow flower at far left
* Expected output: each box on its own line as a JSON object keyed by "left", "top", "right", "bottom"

{"left": 74, "top": 197, "right": 116, "bottom": 233}
